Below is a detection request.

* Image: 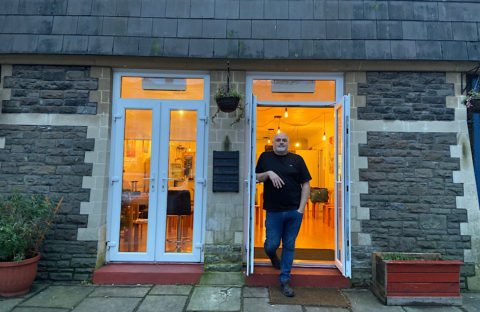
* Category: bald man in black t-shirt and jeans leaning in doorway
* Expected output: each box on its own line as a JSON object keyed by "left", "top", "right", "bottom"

{"left": 255, "top": 133, "right": 312, "bottom": 297}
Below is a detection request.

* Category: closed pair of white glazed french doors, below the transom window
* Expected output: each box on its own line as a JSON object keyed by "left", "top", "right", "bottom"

{"left": 107, "top": 99, "right": 205, "bottom": 262}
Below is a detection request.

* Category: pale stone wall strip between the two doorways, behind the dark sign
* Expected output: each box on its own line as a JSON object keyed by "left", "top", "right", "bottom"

{"left": 204, "top": 71, "right": 246, "bottom": 272}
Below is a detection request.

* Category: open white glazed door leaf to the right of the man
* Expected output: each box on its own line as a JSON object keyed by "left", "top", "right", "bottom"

{"left": 335, "top": 94, "right": 351, "bottom": 277}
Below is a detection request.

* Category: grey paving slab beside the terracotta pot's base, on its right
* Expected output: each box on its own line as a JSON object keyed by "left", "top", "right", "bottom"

{"left": 21, "top": 286, "right": 94, "bottom": 309}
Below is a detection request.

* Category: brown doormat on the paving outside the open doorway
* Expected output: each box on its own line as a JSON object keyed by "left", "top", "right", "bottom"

{"left": 269, "top": 285, "right": 350, "bottom": 308}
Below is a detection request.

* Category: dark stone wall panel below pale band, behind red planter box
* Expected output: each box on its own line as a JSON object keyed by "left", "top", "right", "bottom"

{"left": 358, "top": 132, "right": 474, "bottom": 286}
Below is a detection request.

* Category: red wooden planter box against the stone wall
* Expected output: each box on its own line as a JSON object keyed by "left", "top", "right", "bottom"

{"left": 372, "top": 252, "right": 463, "bottom": 305}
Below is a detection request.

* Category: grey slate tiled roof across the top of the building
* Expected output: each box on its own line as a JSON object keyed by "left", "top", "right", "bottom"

{"left": 0, "top": 0, "right": 480, "bottom": 61}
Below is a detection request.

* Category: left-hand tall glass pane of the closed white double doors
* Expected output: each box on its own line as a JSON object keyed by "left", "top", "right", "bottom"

{"left": 119, "top": 109, "right": 152, "bottom": 252}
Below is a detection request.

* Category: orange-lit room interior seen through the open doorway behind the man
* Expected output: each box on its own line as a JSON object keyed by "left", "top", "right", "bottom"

{"left": 254, "top": 105, "right": 335, "bottom": 265}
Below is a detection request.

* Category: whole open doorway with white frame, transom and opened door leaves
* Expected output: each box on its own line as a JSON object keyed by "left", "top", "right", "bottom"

{"left": 244, "top": 73, "right": 351, "bottom": 277}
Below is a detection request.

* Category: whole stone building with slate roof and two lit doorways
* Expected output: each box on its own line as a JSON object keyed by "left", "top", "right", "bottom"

{"left": 0, "top": 0, "right": 480, "bottom": 289}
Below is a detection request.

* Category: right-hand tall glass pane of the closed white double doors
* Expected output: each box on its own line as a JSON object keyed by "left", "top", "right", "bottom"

{"left": 165, "top": 110, "right": 197, "bottom": 253}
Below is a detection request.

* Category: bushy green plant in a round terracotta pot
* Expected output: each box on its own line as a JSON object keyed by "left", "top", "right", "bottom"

{"left": 0, "top": 191, "right": 63, "bottom": 297}
